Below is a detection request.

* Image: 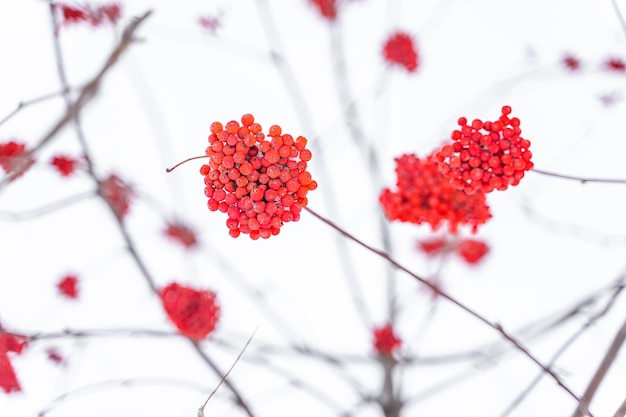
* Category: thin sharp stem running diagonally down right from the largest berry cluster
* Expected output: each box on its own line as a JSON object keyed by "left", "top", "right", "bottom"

{"left": 304, "top": 207, "right": 593, "bottom": 410}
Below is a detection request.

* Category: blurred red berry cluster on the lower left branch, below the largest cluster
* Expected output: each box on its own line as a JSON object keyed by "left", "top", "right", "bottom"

{"left": 159, "top": 283, "right": 220, "bottom": 340}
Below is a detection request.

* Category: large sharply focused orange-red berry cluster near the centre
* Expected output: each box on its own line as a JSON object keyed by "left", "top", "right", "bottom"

{"left": 200, "top": 114, "right": 317, "bottom": 240}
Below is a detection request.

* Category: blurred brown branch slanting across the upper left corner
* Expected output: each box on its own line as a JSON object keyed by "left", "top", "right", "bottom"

{"left": 0, "top": 10, "right": 152, "bottom": 188}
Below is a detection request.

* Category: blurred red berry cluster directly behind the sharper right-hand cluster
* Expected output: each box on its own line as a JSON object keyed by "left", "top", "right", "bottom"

{"left": 379, "top": 155, "right": 491, "bottom": 233}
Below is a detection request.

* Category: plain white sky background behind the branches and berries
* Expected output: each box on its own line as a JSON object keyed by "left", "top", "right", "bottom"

{"left": 0, "top": 0, "right": 626, "bottom": 417}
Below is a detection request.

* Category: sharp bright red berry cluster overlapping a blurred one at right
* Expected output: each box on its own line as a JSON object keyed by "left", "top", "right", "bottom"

{"left": 434, "top": 106, "right": 533, "bottom": 194}
